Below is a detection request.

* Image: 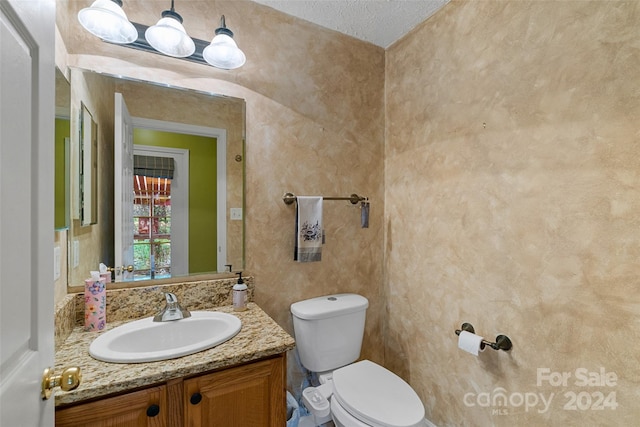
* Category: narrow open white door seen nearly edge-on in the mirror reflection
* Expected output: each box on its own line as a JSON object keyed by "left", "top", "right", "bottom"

{"left": 113, "top": 92, "right": 134, "bottom": 281}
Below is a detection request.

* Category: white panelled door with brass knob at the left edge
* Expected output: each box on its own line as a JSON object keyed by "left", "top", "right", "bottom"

{"left": 0, "top": 0, "right": 55, "bottom": 427}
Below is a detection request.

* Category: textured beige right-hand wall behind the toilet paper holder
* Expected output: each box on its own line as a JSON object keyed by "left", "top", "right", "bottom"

{"left": 384, "top": 1, "right": 640, "bottom": 426}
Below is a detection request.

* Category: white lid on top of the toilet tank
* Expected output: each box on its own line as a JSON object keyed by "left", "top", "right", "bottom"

{"left": 291, "top": 294, "right": 369, "bottom": 320}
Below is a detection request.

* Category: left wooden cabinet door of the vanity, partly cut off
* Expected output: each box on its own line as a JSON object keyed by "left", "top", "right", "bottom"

{"left": 56, "top": 386, "right": 168, "bottom": 427}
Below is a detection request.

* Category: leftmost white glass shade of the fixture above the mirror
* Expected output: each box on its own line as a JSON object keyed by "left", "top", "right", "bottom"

{"left": 78, "top": 0, "right": 138, "bottom": 44}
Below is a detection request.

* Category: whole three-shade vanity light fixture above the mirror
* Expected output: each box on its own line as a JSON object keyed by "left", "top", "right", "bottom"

{"left": 78, "top": 0, "right": 246, "bottom": 70}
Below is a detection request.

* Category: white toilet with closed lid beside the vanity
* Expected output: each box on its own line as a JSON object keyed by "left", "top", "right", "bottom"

{"left": 291, "top": 294, "right": 427, "bottom": 427}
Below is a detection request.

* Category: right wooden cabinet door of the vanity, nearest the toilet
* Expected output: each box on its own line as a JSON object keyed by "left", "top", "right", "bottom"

{"left": 184, "top": 356, "right": 286, "bottom": 427}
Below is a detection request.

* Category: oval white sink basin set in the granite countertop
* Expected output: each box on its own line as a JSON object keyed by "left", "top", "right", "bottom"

{"left": 89, "top": 311, "right": 241, "bottom": 363}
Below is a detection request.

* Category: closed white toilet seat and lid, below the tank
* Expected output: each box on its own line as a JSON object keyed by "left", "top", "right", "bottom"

{"left": 333, "top": 360, "right": 425, "bottom": 427}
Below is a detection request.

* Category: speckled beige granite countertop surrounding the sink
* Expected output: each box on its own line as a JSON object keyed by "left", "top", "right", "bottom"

{"left": 55, "top": 303, "right": 295, "bottom": 406}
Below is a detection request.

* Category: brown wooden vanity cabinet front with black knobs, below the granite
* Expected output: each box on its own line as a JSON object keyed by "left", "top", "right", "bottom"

{"left": 56, "top": 354, "right": 286, "bottom": 427}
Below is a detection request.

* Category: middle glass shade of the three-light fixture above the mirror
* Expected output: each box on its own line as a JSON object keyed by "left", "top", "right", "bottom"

{"left": 144, "top": 16, "right": 196, "bottom": 58}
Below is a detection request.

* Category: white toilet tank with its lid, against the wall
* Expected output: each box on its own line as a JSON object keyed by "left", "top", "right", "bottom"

{"left": 291, "top": 294, "right": 369, "bottom": 372}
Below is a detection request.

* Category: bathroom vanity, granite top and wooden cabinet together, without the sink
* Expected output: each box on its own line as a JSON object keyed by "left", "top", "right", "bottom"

{"left": 55, "top": 303, "right": 295, "bottom": 427}
